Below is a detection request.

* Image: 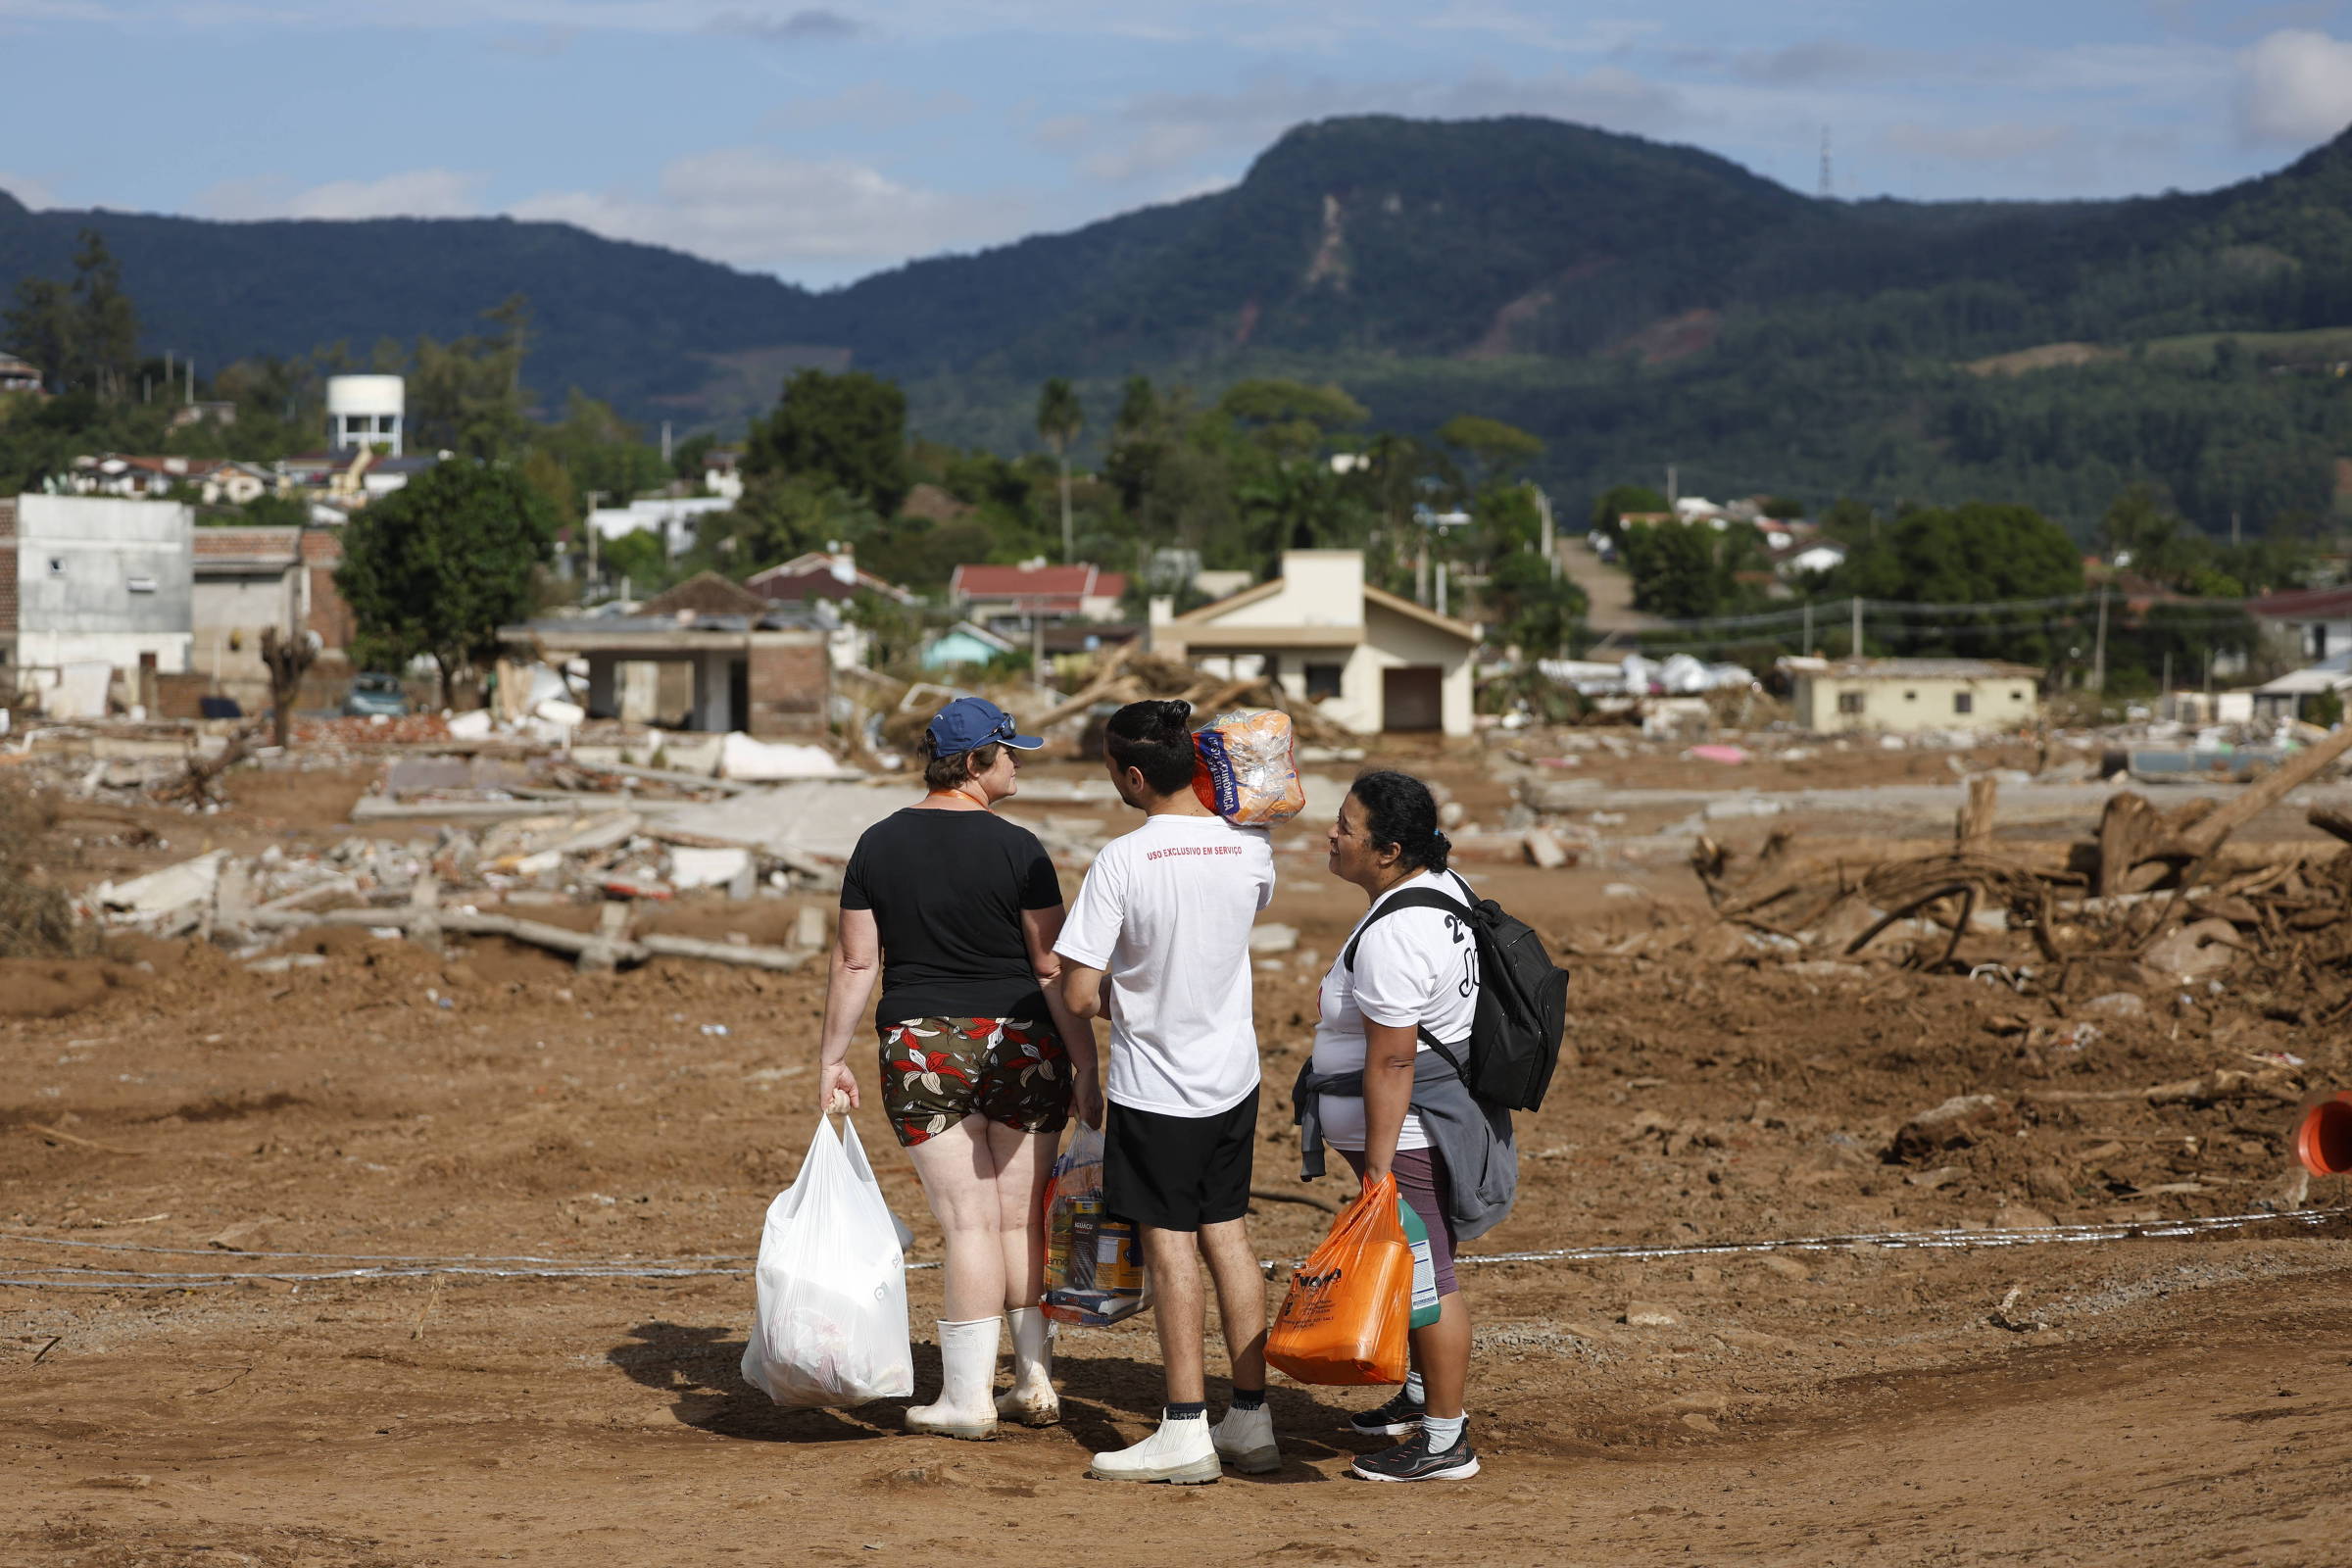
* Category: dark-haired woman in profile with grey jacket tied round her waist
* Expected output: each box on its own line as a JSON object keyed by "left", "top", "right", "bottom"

{"left": 1292, "top": 771, "right": 1517, "bottom": 1481}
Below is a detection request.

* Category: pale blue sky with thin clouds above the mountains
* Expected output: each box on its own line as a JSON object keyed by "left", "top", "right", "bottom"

{"left": 0, "top": 0, "right": 2352, "bottom": 284}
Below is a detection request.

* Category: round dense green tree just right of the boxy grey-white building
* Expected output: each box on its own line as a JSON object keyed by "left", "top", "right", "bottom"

{"left": 334, "top": 459, "right": 555, "bottom": 706}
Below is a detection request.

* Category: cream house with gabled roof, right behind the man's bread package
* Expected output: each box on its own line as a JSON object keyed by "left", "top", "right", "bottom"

{"left": 1151, "top": 550, "right": 1480, "bottom": 736}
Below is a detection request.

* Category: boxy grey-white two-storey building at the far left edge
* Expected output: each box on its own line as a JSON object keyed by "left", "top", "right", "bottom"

{"left": 0, "top": 496, "right": 195, "bottom": 701}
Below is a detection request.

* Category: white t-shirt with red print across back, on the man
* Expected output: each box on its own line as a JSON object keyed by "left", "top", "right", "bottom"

{"left": 1054, "top": 815, "right": 1275, "bottom": 1116}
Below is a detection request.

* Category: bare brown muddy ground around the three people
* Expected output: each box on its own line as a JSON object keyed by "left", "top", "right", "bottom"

{"left": 0, "top": 760, "right": 2352, "bottom": 1568}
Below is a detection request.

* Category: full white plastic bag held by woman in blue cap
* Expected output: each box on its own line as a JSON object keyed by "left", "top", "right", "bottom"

{"left": 743, "top": 1116, "right": 915, "bottom": 1405}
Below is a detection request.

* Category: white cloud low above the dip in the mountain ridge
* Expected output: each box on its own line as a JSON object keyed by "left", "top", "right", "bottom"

{"left": 508, "top": 146, "right": 1033, "bottom": 275}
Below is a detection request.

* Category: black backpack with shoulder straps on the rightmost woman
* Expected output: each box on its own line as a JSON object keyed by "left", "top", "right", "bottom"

{"left": 1343, "top": 874, "right": 1569, "bottom": 1109}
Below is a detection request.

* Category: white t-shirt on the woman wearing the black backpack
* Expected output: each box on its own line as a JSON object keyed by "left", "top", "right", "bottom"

{"left": 1315, "top": 872, "right": 1480, "bottom": 1152}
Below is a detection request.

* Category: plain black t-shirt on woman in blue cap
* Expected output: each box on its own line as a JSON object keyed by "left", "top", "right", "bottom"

{"left": 842, "top": 807, "right": 1060, "bottom": 1025}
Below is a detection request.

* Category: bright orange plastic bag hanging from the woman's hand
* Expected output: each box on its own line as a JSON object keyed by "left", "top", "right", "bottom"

{"left": 1265, "top": 1175, "right": 1413, "bottom": 1385}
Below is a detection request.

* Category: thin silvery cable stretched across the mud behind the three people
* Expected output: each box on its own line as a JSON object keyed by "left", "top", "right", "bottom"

{"left": 0, "top": 1206, "right": 2352, "bottom": 1291}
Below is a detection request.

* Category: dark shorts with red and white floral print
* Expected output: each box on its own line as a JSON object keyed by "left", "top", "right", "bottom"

{"left": 882, "top": 1018, "right": 1072, "bottom": 1148}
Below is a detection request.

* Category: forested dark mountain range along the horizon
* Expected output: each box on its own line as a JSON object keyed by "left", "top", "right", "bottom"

{"left": 0, "top": 116, "right": 2352, "bottom": 526}
